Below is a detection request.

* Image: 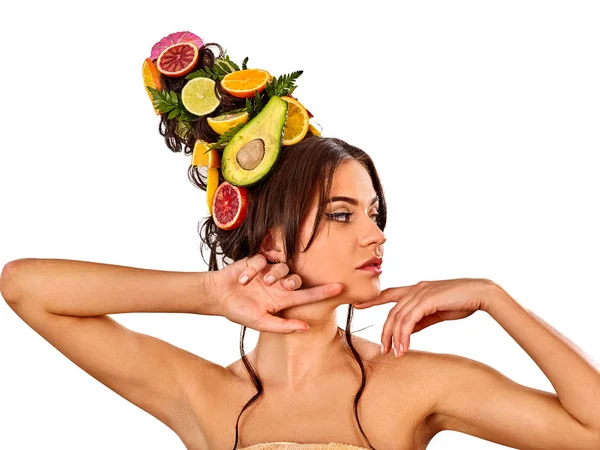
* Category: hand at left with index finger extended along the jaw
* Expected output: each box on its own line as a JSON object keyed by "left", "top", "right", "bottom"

{"left": 208, "top": 253, "right": 343, "bottom": 334}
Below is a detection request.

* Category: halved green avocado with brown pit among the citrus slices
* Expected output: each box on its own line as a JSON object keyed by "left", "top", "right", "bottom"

{"left": 221, "top": 96, "right": 288, "bottom": 186}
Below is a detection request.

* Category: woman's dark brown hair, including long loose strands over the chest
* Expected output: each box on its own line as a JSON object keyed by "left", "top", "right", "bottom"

{"left": 159, "top": 44, "right": 387, "bottom": 450}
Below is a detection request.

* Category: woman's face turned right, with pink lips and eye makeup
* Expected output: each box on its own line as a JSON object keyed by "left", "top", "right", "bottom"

{"left": 296, "top": 160, "right": 386, "bottom": 303}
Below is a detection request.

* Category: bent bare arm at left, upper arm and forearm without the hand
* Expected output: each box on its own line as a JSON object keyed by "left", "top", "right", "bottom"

{"left": 0, "top": 259, "right": 225, "bottom": 443}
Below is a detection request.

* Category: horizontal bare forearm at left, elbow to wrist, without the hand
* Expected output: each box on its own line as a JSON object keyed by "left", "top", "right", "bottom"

{"left": 0, "top": 258, "right": 220, "bottom": 317}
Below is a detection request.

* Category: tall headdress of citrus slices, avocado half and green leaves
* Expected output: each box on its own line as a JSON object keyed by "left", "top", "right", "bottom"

{"left": 142, "top": 31, "right": 321, "bottom": 230}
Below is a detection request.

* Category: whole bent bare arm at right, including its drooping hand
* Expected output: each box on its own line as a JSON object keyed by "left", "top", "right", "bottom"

{"left": 354, "top": 278, "right": 600, "bottom": 450}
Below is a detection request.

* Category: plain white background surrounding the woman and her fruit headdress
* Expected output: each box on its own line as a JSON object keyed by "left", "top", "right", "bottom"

{"left": 0, "top": 0, "right": 600, "bottom": 450}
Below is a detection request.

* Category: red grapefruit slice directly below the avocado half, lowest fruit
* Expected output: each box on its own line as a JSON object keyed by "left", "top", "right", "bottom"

{"left": 212, "top": 181, "right": 248, "bottom": 230}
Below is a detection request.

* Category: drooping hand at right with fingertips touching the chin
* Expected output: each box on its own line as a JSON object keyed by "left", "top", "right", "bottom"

{"left": 354, "top": 278, "right": 498, "bottom": 356}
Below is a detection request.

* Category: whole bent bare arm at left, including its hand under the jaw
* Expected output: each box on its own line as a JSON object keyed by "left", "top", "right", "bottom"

{"left": 0, "top": 253, "right": 332, "bottom": 446}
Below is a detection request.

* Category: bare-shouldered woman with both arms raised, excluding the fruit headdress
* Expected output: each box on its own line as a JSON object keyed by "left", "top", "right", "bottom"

{"left": 2, "top": 36, "right": 600, "bottom": 450}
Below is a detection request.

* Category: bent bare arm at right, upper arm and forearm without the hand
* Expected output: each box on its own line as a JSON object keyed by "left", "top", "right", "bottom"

{"left": 436, "top": 285, "right": 600, "bottom": 450}
